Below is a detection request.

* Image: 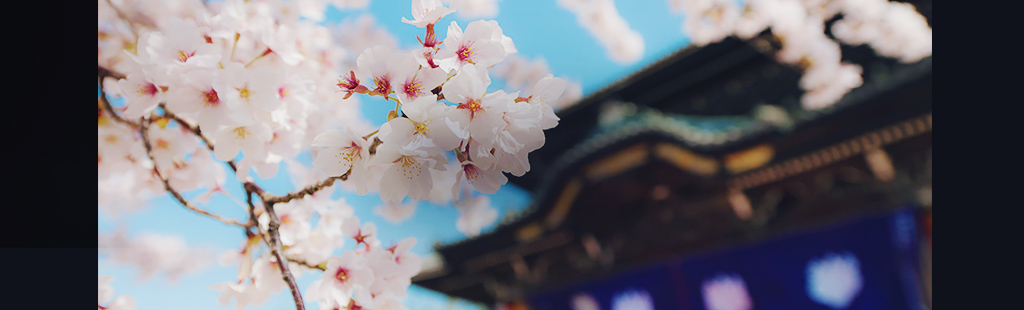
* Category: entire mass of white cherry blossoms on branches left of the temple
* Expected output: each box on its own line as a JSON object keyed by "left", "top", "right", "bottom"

{"left": 97, "top": 0, "right": 579, "bottom": 309}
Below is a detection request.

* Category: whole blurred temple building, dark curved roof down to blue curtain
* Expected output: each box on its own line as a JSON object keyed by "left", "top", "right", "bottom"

{"left": 414, "top": 2, "right": 932, "bottom": 309}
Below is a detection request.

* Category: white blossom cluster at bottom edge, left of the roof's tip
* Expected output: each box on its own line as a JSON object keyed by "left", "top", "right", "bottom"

{"left": 211, "top": 180, "right": 422, "bottom": 309}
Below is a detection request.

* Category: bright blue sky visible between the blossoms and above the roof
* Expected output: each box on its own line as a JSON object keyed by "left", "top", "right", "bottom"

{"left": 98, "top": 0, "right": 688, "bottom": 310}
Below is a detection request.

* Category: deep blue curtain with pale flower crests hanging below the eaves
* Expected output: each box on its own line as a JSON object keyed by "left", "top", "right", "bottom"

{"left": 529, "top": 208, "right": 923, "bottom": 310}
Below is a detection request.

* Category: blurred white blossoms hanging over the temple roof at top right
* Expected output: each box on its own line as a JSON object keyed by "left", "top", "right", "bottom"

{"left": 669, "top": 0, "right": 932, "bottom": 109}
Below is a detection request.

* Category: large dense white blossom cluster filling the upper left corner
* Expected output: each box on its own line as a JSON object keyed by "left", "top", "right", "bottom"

{"left": 99, "top": 0, "right": 369, "bottom": 214}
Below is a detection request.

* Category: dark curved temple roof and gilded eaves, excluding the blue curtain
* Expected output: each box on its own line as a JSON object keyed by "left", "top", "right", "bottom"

{"left": 414, "top": 3, "right": 932, "bottom": 301}
